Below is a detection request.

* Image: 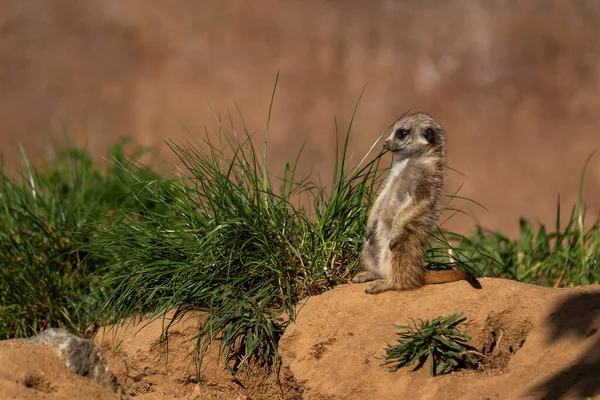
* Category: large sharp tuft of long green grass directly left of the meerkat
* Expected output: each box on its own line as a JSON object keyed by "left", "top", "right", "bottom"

{"left": 95, "top": 93, "right": 381, "bottom": 371}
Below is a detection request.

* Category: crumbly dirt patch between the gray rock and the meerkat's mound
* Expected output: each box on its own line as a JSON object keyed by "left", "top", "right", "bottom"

{"left": 95, "top": 312, "right": 301, "bottom": 400}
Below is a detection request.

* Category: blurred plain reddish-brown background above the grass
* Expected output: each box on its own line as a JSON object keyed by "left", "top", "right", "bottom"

{"left": 0, "top": 0, "right": 600, "bottom": 234}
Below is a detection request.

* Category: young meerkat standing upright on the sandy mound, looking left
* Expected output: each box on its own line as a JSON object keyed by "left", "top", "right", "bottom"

{"left": 352, "top": 113, "right": 481, "bottom": 294}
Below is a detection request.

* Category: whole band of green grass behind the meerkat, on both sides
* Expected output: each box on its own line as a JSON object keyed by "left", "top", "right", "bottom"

{"left": 0, "top": 90, "right": 599, "bottom": 376}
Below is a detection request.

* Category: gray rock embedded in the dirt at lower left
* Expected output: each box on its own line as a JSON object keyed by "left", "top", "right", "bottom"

{"left": 25, "top": 328, "right": 129, "bottom": 400}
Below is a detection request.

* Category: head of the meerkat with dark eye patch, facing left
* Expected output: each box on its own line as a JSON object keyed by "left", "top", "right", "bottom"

{"left": 383, "top": 113, "right": 446, "bottom": 158}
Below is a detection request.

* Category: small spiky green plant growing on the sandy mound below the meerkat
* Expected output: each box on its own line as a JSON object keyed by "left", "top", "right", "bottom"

{"left": 383, "top": 313, "right": 478, "bottom": 376}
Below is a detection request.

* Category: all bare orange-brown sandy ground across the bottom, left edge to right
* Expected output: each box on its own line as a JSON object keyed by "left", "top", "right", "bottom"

{"left": 0, "top": 278, "right": 600, "bottom": 399}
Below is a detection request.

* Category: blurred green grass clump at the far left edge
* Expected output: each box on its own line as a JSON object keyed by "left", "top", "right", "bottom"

{"left": 0, "top": 141, "right": 164, "bottom": 339}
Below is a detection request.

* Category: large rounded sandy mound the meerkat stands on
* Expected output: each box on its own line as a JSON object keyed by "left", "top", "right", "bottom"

{"left": 280, "top": 279, "right": 600, "bottom": 399}
